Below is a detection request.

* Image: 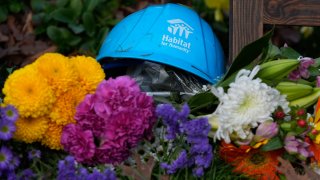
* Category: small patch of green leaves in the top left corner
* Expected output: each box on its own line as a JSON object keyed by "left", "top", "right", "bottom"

{"left": 0, "top": 0, "right": 24, "bottom": 23}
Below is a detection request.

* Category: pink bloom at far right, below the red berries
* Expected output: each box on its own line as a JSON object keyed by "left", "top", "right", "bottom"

{"left": 284, "top": 135, "right": 313, "bottom": 160}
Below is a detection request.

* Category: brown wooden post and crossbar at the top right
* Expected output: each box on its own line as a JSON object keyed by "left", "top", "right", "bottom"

{"left": 229, "top": 0, "right": 320, "bottom": 61}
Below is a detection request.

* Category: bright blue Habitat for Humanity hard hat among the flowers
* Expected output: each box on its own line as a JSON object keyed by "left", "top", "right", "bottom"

{"left": 97, "top": 3, "right": 225, "bottom": 83}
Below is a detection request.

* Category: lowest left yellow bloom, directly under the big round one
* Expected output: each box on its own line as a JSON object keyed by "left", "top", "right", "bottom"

{"left": 13, "top": 117, "right": 49, "bottom": 143}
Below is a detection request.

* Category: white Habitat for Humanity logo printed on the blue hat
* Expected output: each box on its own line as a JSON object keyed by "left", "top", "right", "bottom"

{"left": 161, "top": 19, "right": 193, "bottom": 53}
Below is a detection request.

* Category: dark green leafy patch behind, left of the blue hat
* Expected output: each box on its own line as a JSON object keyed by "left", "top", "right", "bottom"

{"left": 31, "top": 0, "right": 120, "bottom": 55}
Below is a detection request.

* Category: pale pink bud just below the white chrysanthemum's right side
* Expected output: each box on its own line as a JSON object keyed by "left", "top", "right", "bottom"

{"left": 254, "top": 121, "right": 279, "bottom": 142}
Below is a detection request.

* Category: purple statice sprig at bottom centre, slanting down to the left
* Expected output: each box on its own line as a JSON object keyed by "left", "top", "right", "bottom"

{"left": 160, "top": 150, "right": 191, "bottom": 174}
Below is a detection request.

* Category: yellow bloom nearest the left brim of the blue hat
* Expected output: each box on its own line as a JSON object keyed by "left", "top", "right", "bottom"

{"left": 71, "top": 56, "right": 105, "bottom": 93}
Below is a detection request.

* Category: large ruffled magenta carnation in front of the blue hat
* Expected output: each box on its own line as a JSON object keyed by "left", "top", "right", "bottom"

{"left": 64, "top": 76, "right": 156, "bottom": 164}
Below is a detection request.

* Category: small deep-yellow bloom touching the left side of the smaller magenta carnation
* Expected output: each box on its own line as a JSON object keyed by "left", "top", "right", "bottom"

{"left": 41, "top": 122, "right": 64, "bottom": 150}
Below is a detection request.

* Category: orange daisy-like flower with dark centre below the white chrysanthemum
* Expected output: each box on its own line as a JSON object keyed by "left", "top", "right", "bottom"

{"left": 219, "top": 143, "right": 281, "bottom": 180}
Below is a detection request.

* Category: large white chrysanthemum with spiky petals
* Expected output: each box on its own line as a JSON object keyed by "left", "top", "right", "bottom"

{"left": 211, "top": 66, "right": 290, "bottom": 143}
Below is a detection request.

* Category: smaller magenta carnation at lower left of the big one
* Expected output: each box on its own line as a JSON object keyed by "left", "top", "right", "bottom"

{"left": 61, "top": 124, "right": 95, "bottom": 162}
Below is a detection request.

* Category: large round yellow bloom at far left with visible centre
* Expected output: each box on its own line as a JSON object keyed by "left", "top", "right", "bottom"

{"left": 3, "top": 65, "right": 55, "bottom": 118}
